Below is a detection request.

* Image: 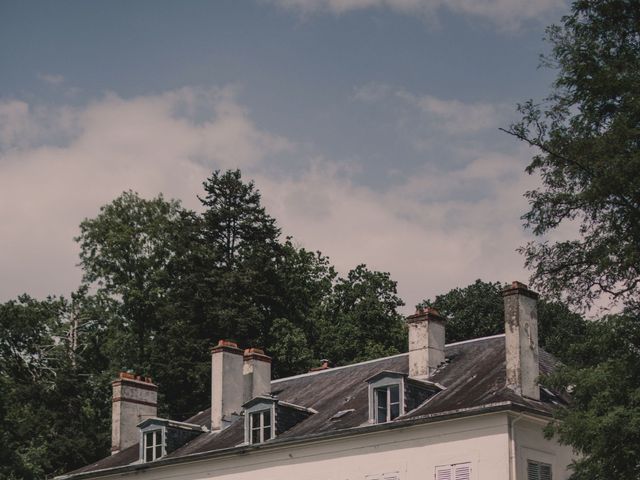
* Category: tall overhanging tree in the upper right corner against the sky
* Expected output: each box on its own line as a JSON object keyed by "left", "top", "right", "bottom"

{"left": 508, "top": 0, "right": 640, "bottom": 308}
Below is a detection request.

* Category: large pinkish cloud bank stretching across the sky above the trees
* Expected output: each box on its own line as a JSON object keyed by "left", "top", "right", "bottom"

{"left": 0, "top": 88, "right": 533, "bottom": 312}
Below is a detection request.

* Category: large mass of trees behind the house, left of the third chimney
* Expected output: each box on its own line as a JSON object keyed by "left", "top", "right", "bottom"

{"left": 0, "top": 170, "right": 405, "bottom": 479}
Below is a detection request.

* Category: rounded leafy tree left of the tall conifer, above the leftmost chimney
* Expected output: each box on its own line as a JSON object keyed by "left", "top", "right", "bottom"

{"left": 76, "top": 191, "right": 182, "bottom": 371}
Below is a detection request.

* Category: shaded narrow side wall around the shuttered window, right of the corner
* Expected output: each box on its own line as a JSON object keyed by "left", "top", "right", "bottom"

{"left": 513, "top": 416, "right": 574, "bottom": 480}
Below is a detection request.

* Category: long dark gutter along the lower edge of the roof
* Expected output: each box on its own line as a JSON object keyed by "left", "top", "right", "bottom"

{"left": 54, "top": 401, "right": 551, "bottom": 480}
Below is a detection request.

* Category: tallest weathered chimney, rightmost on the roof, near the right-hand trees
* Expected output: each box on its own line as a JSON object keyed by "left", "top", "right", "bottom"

{"left": 502, "top": 282, "right": 540, "bottom": 400}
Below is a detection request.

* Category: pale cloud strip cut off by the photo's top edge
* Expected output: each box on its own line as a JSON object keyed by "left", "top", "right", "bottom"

{"left": 271, "top": 0, "right": 565, "bottom": 30}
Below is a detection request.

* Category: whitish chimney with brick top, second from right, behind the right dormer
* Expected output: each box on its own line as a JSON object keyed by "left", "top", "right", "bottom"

{"left": 407, "top": 307, "right": 445, "bottom": 379}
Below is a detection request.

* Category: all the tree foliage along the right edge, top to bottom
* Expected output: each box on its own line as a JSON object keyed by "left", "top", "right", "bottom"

{"left": 509, "top": 0, "right": 640, "bottom": 479}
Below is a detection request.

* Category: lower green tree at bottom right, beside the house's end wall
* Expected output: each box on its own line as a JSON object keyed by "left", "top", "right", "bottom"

{"left": 544, "top": 314, "right": 640, "bottom": 480}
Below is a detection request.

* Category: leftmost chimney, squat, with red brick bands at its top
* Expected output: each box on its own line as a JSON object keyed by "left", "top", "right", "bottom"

{"left": 111, "top": 372, "right": 158, "bottom": 455}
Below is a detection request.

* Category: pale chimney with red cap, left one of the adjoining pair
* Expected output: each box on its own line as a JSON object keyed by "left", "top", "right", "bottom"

{"left": 211, "top": 340, "right": 244, "bottom": 430}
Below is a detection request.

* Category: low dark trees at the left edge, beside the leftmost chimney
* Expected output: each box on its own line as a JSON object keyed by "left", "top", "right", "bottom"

{"left": 0, "top": 292, "right": 110, "bottom": 479}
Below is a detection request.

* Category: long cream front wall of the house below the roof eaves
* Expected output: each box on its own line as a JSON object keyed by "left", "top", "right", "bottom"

{"left": 95, "top": 413, "right": 509, "bottom": 480}
